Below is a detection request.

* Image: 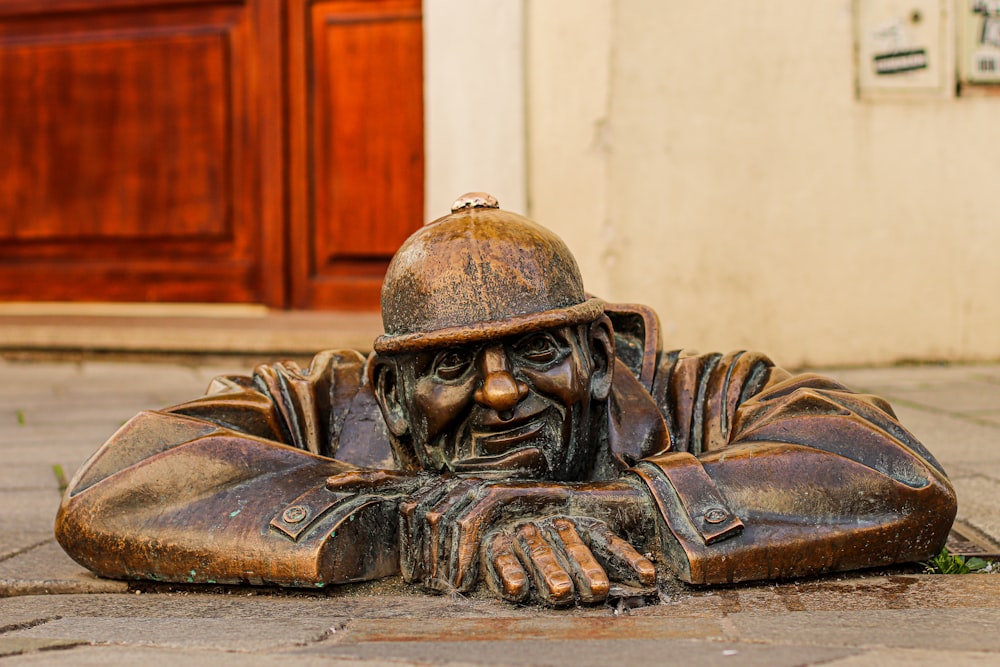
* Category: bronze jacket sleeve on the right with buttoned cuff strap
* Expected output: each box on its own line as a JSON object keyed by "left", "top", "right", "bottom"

{"left": 631, "top": 353, "right": 956, "bottom": 583}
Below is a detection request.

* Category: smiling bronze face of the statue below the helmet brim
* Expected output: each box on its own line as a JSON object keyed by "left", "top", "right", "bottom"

{"left": 384, "top": 325, "right": 607, "bottom": 480}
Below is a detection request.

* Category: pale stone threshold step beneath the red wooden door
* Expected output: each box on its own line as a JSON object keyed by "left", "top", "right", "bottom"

{"left": 0, "top": 303, "right": 382, "bottom": 355}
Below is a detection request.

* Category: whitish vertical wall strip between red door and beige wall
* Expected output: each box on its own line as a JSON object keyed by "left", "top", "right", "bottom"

{"left": 423, "top": 0, "right": 527, "bottom": 220}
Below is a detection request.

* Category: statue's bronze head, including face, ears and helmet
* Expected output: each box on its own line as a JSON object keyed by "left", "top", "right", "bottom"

{"left": 372, "top": 195, "right": 614, "bottom": 480}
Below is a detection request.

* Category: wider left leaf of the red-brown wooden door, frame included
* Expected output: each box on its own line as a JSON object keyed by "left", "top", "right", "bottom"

{"left": 0, "top": 0, "right": 285, "bottom": 306}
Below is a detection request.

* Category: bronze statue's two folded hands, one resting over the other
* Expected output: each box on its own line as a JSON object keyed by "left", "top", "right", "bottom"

{"left": 400, "top": 477, "right": 656, "bottom": 604}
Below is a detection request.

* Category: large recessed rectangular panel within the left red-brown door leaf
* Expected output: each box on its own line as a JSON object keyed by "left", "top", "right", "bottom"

{"left": 0, "top": 27, "right": 232, "bottom": 240}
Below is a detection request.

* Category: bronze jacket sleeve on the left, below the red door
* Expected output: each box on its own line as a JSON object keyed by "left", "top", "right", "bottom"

{"left": 56, "top": 354, "right": 398, "bottom": 586}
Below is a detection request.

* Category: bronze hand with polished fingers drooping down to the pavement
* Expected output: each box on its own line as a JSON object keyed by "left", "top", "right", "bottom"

{"left": 482, "top": 517, "right": 656, "bottom": 606}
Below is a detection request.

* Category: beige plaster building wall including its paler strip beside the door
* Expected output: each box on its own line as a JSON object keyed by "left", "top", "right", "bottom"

{"left": 425, "top": 0, "right": 1000, "bottom": 365}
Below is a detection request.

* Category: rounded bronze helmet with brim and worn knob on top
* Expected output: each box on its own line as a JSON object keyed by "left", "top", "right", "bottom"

{"left": 374, "top": 193, "right": 604, "bottom": 354}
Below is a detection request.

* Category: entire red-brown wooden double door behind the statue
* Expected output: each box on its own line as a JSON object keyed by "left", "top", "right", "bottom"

{"left": 0, "top": 0, "right": 423, "bottom": 309}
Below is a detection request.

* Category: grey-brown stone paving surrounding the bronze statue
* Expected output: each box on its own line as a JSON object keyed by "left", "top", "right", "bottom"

{"left": 0, "top": 355, "right": 1000, "bottom": 667}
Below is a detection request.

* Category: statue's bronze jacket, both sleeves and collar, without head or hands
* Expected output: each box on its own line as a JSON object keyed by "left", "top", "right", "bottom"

{"left": 56, "top": 306, "right": 956, "bottom": 586}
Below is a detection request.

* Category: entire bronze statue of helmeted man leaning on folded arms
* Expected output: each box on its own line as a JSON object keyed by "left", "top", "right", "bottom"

{"left": 56, "top": 194, "right": 956, "bottom": 605}
